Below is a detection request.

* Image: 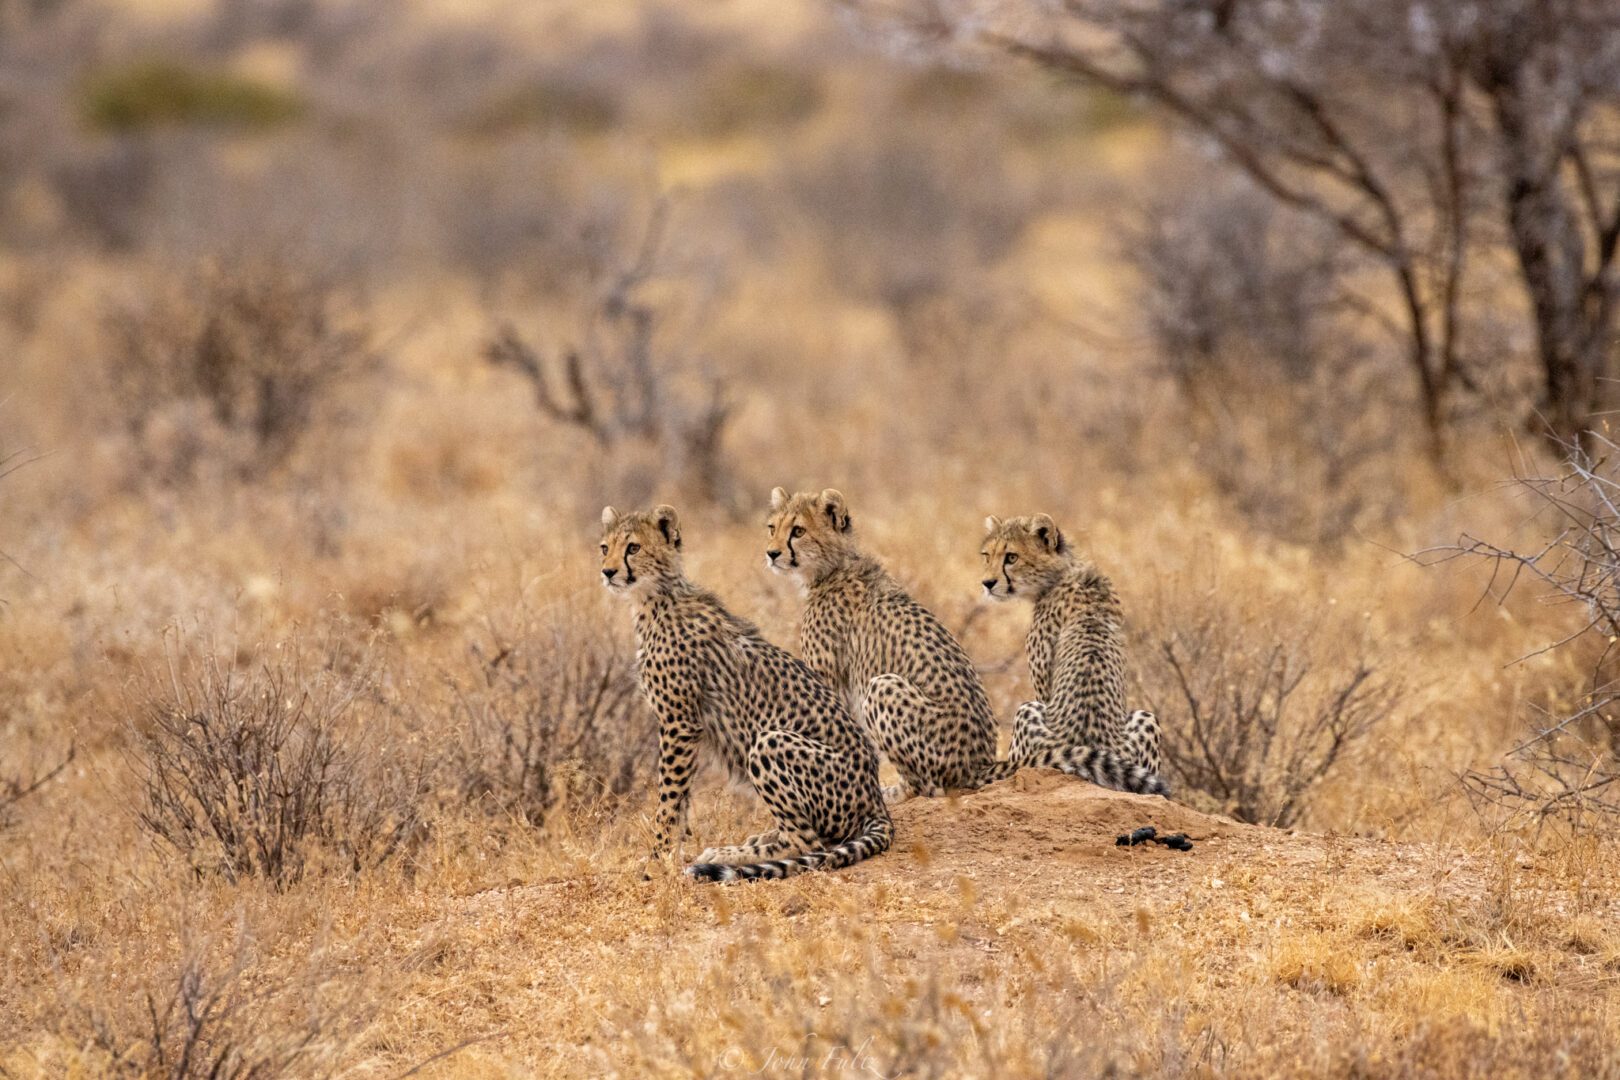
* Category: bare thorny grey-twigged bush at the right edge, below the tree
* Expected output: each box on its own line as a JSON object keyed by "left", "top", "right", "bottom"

{"left": 1414, "top": 432, "right": 1620, "bottom": 827}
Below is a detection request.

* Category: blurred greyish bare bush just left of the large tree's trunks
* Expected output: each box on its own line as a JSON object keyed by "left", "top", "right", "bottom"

{"left": 1124, "top": 168, "right": 1414, "bottom": 544}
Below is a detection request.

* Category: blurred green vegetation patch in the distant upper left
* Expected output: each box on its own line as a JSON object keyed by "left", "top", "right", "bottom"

{"left": 79, "top": 60, "right": 306, "bottom": 131}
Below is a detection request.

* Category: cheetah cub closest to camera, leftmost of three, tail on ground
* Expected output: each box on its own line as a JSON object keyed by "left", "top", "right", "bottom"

{"left": 601, "top": 507, "right": 894, "bottom": 881}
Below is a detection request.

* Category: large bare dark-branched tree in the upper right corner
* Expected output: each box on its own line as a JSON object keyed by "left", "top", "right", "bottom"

{"left": 844, "top": 0, "right": 1620, "bottom": 455}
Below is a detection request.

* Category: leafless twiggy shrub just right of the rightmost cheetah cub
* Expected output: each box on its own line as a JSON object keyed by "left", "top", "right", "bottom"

{"left": 1136, "top": 607, "right": 1401, "bottom": 827}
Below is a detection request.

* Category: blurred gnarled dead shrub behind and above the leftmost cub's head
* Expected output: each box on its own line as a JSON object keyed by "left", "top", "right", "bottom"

{"left": 484, "top": 202, "right": 734, "bottom": 502}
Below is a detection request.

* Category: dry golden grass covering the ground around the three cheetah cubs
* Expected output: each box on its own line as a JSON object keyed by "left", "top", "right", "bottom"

{"left": 0, "top": 5, "right": 1620, "bottom": 1077}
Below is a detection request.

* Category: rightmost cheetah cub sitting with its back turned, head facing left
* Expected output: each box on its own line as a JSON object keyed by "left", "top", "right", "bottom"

{"left": 980, "top": 513, "right": 1170, "bottom": 795}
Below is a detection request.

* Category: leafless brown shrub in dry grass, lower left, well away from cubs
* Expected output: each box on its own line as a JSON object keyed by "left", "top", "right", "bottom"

{"left": 133, "top": 646, "right": 428, "bottom": 887}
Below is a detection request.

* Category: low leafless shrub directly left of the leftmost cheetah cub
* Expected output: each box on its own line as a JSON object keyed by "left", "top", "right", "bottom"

{"left": 452, "top": 620, "right": 658, "bottom": 826}
